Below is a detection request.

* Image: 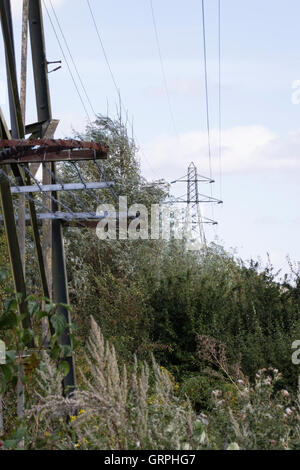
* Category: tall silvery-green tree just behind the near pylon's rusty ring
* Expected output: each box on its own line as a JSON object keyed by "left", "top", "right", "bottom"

{"left": 61, "top": 116, "right": 167, "bottom": 358}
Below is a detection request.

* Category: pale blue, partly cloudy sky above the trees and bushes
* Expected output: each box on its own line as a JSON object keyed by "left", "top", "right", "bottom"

{"left": 0, "top": 0, "right": 300, "bottom": 278}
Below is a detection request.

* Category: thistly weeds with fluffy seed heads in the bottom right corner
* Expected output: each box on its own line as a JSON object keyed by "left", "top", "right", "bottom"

{"left": 207, "top": 367, "right": 300, "bottom": 450}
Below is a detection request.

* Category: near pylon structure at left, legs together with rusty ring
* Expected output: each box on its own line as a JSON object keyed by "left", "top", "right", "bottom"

{"left": 0, "top": 0, "right": 107, "bottom": 402}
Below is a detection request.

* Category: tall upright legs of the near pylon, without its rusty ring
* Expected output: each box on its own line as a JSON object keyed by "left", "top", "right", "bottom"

{"left": 0, "top": 0, "right": 75, "bottom": 394}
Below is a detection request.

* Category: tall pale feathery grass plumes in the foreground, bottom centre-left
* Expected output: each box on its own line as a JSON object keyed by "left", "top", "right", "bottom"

{"left": 27, "top": 319, "right": 201, "bottom": 450}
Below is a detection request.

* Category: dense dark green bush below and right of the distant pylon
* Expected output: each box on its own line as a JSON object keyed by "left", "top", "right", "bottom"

{"left": 144, "top": 246, "right": 300, "bottom": 387}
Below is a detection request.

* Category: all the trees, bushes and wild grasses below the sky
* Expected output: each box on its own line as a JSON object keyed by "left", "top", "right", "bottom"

{"left": 0, "top": 116, "right": 300, "bottom": 449}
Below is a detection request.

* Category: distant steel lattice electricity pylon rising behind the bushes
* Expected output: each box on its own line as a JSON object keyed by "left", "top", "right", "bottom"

{"left": 171, "top": 162, "right": 222, "bottom": 249}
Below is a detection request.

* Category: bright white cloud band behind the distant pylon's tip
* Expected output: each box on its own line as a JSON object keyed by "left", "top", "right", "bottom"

{"left": 143, "top": 126, "right": 300, "bottom": 180}
